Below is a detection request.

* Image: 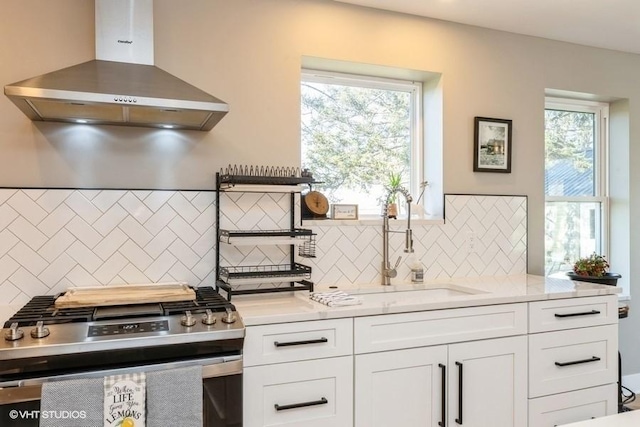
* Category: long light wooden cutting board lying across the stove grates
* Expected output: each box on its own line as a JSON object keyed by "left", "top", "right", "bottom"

{"left": 54, "top": 283, "right": 196, "bottom": 308}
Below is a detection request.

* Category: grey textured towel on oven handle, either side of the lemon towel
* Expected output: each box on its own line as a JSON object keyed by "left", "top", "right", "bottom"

{"left": 40, "top": 366, "right": 203, "bottom": 427}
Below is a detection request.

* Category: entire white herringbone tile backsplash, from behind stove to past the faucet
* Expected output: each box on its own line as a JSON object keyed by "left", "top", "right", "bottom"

{"left": 0, "top": 189, "right": 527, "bottom": 305}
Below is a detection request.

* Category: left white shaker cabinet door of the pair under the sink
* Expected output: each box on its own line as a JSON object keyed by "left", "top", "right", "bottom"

{"left": 355, "top": 346, "right": 447, "bottom": 427}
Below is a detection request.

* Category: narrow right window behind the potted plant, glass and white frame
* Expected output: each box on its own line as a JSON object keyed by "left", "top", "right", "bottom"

{"left": 545, "top": 99, "right": 609, "bottom": 274}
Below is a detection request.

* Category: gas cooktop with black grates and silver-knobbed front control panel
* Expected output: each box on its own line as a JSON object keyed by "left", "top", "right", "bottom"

{"left": 0, "top": 287, "right": 244, "bottom": 362}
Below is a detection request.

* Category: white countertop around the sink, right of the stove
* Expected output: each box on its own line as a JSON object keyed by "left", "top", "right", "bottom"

{"left": 232, "top": 275, "right": 621, "bottom": 326}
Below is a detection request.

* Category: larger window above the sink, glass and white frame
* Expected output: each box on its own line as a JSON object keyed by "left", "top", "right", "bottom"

{"left": 300, "top": 70, "right": 423, "bottom": 217}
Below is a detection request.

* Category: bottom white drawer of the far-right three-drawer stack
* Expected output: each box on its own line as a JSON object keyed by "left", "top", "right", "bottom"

{"left": 529, "top": 384, "right": 618, "bottom": 427}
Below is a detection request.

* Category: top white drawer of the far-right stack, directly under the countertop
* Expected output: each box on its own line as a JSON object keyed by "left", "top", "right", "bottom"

{"left": 529, "top": 295, "right": 618, "bottom": 333}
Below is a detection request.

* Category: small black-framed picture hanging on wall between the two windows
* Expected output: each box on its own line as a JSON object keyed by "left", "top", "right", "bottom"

{"left": 473, "top": 117, "right": 511, "bottom": 173}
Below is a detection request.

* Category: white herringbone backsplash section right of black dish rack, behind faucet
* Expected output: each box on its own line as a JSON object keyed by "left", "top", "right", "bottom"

{"left": 302, "top": 195, "right": 527, "bottom": 285}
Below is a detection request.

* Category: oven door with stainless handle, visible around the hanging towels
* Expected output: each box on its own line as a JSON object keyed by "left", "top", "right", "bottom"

{"left": 0, "top": 356, "right": 242, "bottom": 427}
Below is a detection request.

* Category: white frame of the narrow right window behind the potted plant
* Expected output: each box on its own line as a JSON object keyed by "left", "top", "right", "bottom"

{"left": 544, "top": 97, "right": 610, "bottom": 264}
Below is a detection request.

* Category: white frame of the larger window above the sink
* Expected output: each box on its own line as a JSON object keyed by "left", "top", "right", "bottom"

{"left": 300, "top": 68, "right": 425, "bottom": 219}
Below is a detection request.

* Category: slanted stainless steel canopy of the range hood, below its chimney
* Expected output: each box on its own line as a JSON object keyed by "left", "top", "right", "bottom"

{"left": 4, "top": 60, "right": 229, "bottom": 130}
